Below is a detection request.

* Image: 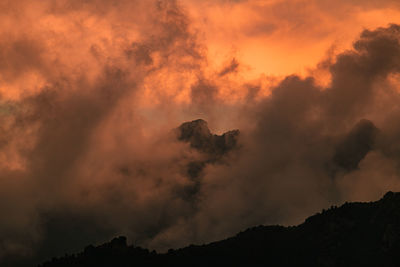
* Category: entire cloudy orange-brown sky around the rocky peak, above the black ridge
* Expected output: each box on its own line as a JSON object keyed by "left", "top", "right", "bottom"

{"left": 0, "top": 0, "right": 400, "bottom": 266}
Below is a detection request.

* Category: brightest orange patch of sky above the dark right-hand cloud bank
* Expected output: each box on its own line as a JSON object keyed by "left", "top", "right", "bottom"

{"left": 185, "top": 0, "right": 400, "bottom": 80}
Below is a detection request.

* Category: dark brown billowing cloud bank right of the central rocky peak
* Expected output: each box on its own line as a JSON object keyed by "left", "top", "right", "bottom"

{"left": 154, "top": 22, "right": 400, "bottom": 249}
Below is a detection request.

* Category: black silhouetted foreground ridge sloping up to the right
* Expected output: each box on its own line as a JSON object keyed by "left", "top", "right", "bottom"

{"left": 41, "top": 192, "right": 400, "bottom": 267}
